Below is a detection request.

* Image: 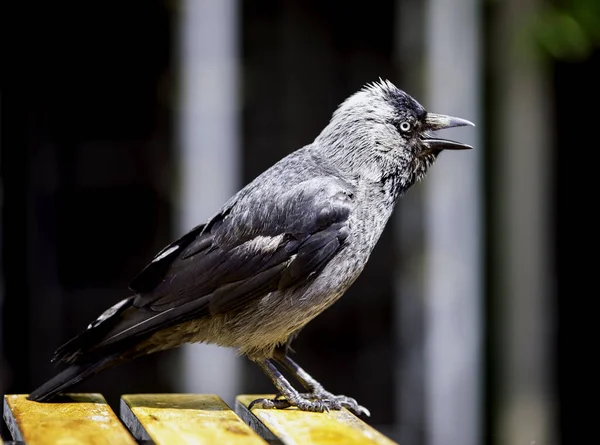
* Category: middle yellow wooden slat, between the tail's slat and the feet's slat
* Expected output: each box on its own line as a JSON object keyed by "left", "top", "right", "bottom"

{"left": 120, "top": 394, "right": 265, "bottom": 445}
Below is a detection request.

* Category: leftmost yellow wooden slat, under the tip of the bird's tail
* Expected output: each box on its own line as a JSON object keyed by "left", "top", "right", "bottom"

{"left": 4, "top": 394, "right": 136, "bottom": 445}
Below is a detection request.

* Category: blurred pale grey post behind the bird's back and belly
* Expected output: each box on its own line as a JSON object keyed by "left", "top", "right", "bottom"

{"left": 177, "top": 0, "right": 240, "bottom": 403}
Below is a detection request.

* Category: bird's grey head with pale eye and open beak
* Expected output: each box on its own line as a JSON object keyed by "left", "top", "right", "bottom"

{"left": 315, "top": 80, "right": 474, "bottom": 188}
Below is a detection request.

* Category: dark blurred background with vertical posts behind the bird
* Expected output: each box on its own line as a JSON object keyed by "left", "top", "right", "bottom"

{"left": 0, "top": 0, "right": 600, "bottom": 445}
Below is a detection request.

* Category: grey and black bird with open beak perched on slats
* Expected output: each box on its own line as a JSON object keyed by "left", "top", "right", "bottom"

{"left": 28, "top": 78, "right": 474, "bottom": 415}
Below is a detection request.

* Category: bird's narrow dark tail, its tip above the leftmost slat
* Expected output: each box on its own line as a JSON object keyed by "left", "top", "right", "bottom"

{"left": 27, "top": 354, "right": 122, "bottom": 402}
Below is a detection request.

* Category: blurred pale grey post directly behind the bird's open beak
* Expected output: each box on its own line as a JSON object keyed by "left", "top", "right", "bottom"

{"left": 424, "top": 0, "right": 483, "bottom": 445}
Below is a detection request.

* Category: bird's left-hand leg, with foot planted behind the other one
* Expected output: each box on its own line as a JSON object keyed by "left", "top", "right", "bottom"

{"left": 248, "top": 359, "right": 330, "bottom": 413}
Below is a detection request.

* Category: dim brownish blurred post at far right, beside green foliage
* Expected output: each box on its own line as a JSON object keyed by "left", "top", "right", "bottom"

{"left": 493, "top": 0, "right": 556, "bottom": 445}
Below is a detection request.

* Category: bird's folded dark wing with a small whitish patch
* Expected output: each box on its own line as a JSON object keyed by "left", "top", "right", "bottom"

{"left": 57, "top": 177, "right": 356, "bottom": 359}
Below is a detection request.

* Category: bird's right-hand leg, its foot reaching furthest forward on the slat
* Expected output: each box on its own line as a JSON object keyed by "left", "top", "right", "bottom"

{"left": 275, "top": 351, "right": 371, "bottom": 416}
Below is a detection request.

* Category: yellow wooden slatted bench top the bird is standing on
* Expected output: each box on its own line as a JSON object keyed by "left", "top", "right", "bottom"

{"left": 5, "top": 394, "right": 395, "bottom": 445}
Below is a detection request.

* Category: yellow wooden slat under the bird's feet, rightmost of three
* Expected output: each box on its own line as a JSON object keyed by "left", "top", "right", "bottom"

{"left": 235, "top": 394, "right": 395, "bottom": 445}
